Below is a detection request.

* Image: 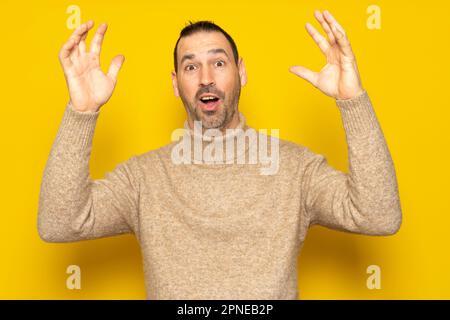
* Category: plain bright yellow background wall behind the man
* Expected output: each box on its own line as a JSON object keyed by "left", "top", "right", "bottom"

{"left": 0, "top": 0, "right": 450, "bottom": 299}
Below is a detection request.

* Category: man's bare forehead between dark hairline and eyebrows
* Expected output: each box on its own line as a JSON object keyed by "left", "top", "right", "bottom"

{"left": 178, "top": 32, "right": 231, "bottom": 58}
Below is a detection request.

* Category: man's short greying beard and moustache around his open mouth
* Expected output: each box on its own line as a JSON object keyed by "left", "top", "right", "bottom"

{"left": 180, "top": 81, "right": 241, "bottom": 129}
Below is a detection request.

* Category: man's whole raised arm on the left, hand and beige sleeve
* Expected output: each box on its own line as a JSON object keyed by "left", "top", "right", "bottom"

{"left": 38, "top": 20, "right": 132, "bottom": 242}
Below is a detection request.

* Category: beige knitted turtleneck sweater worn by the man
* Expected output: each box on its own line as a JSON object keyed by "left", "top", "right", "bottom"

{"left": 38, "top": 92, "right": 402, "bottom": 299}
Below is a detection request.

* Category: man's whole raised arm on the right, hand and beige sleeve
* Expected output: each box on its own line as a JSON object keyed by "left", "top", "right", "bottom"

{"left": 289, "top": 10, "right": 402, "bottom": 235}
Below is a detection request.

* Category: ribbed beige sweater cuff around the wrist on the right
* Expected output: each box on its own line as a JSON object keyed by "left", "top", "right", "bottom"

{"left": 336, "top": 90, "right": 378, "bottom": 134}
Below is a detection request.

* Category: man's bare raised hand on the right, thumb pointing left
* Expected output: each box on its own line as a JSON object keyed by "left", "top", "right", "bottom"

{"left": 289, "top": 10, "right": 364, "bottom": 99}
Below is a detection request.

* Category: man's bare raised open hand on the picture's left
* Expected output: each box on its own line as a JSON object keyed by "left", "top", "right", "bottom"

{"left": 59, "top": 20, "right": 125, "bottom": 112}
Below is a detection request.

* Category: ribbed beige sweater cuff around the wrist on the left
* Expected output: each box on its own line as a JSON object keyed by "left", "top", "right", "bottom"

{"left": 56, "top": 102, "right": 100, "bottom": 149}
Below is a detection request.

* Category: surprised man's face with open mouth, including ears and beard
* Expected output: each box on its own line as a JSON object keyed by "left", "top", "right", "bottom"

{"left": 172, "top": 31, "right": 247, "bottom": 129}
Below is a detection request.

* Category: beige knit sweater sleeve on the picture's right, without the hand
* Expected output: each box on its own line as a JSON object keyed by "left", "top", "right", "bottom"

{"left": 302, "top": 91, "right": 402, "bottom": 235}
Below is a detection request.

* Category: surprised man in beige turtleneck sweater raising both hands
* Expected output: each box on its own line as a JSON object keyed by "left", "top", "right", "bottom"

{"left": 38, "top": 11, "right": 402, "bottom": 299}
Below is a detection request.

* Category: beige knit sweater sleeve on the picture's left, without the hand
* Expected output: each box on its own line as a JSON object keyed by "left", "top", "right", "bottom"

{"left": 38, "top": 103, "right": 139, "bottom": 242}
